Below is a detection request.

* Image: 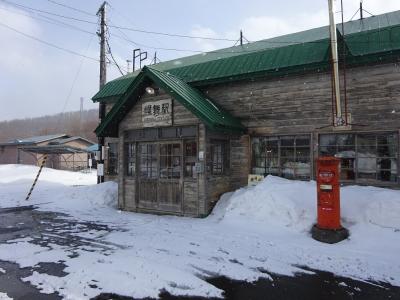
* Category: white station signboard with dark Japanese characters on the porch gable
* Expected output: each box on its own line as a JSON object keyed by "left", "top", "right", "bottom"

{"left": 142, "top": 99, "right": 172, "bottom": 127}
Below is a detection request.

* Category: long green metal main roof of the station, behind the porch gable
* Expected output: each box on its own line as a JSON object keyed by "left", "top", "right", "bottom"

{"left": 92, "top": 11, "right": 400, "bottom": 101}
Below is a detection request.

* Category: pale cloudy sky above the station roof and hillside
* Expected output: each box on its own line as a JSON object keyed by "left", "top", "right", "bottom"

{"left": 0, "top": 0, "right": 400, "bottom": 121}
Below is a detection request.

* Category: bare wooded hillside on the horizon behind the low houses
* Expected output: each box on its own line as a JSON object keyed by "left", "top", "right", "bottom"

{"left": 0, "top": 109, "right": 99, "bottom": 142}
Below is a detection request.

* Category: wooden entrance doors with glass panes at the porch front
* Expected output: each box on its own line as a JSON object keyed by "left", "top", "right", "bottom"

{"left": 138, "top": 142, "right": 183, "bottom": 212}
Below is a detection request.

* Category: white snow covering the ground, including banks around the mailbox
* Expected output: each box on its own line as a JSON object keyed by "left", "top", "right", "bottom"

{"left": 0, "top": 165, "right": 400, "bottom": 300}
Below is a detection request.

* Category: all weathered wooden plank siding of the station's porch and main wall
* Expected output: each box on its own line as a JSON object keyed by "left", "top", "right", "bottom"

{"left": 102, "top": 63, "right": 400, "bottom": 216}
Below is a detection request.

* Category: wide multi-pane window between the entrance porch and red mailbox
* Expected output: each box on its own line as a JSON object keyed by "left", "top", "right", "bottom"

{"left": 252, "top": 135, "right": 311, "bottom": 179}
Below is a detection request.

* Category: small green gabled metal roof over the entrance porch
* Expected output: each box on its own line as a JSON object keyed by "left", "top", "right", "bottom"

{"left": 95, "top": 67, "right": 245, "bottom": 136}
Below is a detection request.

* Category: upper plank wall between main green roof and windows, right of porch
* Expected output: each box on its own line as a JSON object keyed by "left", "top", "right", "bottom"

{"left": 203, "top": 63, "right": 400, "bottom": 135}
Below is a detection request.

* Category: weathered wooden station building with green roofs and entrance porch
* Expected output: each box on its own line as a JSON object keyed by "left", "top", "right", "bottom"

{"left": 93, "top": 11, "right": 400, "bottom": 216}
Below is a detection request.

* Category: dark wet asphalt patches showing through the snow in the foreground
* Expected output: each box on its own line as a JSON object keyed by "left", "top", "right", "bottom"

{"left": 0, "top": 206, "right": 400, "bottom": 300}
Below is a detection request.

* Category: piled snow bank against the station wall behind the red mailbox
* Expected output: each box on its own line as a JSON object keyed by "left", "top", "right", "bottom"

{"left": 212, "top": 176, "right": 400, "bottom": 231}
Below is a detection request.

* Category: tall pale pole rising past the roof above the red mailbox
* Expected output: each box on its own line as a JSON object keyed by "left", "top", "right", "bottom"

{"left": 328, "top": 0, "right": 344, "bottom": 126}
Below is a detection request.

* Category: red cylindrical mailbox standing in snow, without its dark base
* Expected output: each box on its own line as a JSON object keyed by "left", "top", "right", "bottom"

{"left": 317, "top": 157, "right": 342, "bottom": 230}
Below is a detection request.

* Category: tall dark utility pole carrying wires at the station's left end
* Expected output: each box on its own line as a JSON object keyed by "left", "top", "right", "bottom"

{"left": 96, "top": 1, "right": 107, "bottom": 183}
